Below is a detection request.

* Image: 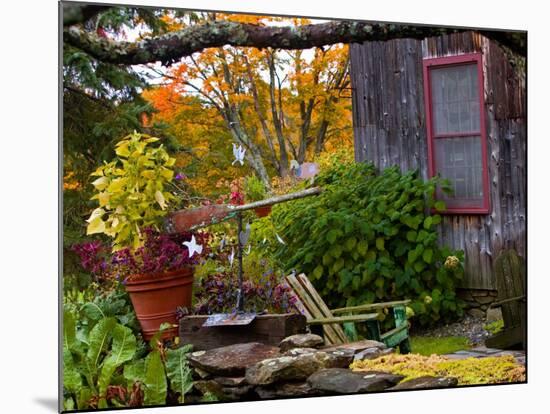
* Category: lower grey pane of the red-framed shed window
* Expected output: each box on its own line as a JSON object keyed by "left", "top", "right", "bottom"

{"left": 434, "top": 136, "right": 483, "bottom": 208}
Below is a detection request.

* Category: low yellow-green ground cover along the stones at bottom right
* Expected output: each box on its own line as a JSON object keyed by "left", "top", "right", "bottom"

{"left": 350, "top": 354, "right": 525, "bottom": 385}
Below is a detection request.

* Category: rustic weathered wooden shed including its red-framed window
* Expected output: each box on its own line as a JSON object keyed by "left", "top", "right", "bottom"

{"left": 350, "top": 32, "right": 527, "bottom": 296}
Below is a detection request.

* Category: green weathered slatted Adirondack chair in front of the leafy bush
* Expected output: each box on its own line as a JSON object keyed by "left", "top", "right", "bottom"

{"left": 285, "top": 274, "right": 410, "bottom": 353}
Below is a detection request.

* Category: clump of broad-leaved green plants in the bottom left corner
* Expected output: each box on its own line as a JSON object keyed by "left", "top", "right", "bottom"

{"left": 63, "top": 291, "right": 196, "bottom": 410}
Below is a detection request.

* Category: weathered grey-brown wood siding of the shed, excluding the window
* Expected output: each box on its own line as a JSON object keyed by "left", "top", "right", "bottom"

{"left": 350, "top": 32, "right": 527, "bottom": 289}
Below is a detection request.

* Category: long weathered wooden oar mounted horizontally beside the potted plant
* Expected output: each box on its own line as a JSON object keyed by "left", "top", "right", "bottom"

{"left": 165, "top": 187, "right": 322, "bottom": 233}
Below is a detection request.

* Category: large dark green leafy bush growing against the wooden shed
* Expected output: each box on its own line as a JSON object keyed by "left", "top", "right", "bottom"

{"left": 260, "top": 152, "right": 463, "bottom": 325}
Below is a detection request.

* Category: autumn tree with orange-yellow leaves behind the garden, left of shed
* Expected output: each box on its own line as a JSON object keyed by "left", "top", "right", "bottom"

{"left": 142, "top": 13, "right": 351, "bottom": 187}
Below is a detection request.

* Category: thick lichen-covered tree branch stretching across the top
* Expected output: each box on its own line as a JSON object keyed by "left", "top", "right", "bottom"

{"left": 64, "top": 20, "right": 527, "bottom": 65}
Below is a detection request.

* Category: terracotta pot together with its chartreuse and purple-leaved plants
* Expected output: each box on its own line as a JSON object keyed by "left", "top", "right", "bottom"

{"left": 81, "top": 133, "right": 207, "bottom": 339}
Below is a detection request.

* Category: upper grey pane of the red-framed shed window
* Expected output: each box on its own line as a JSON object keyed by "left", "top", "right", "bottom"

{"left": 430, "top": 64, "right": 479, "bottom": 134}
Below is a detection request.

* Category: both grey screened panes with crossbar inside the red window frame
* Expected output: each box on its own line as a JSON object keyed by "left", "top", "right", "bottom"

{"left": 426, "top": 58, "right": 488, "bottom": 211}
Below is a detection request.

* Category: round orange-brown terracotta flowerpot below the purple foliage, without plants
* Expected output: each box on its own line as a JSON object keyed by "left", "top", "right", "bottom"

{"left": 126, "top": 267, "right": 193, "bottom": 340}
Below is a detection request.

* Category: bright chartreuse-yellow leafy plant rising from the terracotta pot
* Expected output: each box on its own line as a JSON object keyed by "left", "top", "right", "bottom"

{"left": 87, "top": 132, "right": 176, "bottom": 250}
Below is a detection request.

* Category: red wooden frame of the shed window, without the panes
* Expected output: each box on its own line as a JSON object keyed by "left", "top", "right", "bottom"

{"left": 423, "top": 53, "right": 490, "bottom": 214}
